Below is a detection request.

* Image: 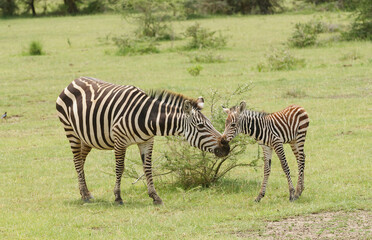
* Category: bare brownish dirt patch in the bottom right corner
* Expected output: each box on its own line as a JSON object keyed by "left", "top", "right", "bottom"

{"left": 235, "top": 210, "right": 372, "bottom": 240}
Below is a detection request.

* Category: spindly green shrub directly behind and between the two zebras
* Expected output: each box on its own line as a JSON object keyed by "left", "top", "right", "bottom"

{"left": 159, "top": 85, "right": 259, "bottom": 189}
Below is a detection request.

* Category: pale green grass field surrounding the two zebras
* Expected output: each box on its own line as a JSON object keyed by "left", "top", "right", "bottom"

{"left": 0, "top": 13, "right": 372, "bottom": 239}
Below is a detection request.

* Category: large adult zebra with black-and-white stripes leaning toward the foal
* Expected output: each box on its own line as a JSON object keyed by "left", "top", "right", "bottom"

{"left": 56, "top": 77, "right": 230, "bottom": 204}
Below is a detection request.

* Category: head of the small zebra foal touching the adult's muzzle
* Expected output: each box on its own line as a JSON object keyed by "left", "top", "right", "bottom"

{"left": 221, "top": 101, "right": 246, "bottom": 143}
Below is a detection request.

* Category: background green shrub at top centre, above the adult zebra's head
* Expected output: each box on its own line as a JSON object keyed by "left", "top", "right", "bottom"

{"left": 185, "top": 23, "right": 227, "bottom": 49}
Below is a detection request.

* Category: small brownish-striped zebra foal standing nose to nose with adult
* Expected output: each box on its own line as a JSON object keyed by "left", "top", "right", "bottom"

{"left": 221, "top": 101, "right": 309, "bottom": 202}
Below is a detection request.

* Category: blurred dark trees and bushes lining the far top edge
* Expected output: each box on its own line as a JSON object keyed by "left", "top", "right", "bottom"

{"left": 0, "top": 0, "right": 372, "bottom": 40}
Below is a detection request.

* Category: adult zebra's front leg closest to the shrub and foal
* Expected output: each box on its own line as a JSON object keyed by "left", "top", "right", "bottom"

{"left": 137, "top": 138, "right": 163, "bottom": 205}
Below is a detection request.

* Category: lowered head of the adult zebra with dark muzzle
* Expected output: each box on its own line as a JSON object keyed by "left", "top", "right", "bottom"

{"left": 183, "top": 97, "right": 230, "bottom": 157}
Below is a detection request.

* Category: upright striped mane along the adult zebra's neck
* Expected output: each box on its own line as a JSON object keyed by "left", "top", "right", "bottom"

{"left": 146, "top": 90, "right": 201, "bottom": 110}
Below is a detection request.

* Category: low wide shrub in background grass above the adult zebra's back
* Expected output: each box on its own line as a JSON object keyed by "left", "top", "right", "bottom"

{"left": 112, "top": 36, "right": 159, "bottom": 56}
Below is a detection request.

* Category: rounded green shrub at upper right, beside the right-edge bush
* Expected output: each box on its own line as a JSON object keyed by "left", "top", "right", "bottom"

{"left": 288, "top": 21, "right": 325, "bottom": 48}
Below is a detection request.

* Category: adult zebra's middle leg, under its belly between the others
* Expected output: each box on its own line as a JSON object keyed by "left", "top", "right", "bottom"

{"left": 114, "top": 139, "right": 127, "bottom": 205}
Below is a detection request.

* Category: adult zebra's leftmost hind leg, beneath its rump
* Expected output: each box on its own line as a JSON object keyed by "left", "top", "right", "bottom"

{"left": 69, "top": 136, "right": 91, "bottom": 202}
